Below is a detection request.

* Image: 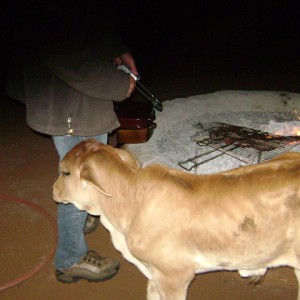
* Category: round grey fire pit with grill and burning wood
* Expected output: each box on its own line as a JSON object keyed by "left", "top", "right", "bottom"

{"left": 126, "top": 91, "right": 300, "bottom": 174}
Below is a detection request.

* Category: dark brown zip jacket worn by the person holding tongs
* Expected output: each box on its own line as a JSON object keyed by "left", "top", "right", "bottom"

{"left": 7, "top": 0, "right": 130, "bottom": 136}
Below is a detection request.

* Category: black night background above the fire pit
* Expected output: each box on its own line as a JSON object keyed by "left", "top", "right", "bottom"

{"left": 1, "top": 0, "right": 300, "bottom": 97}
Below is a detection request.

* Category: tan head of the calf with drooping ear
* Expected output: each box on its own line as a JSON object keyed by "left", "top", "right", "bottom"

{"left": 53, "top": 139, "right": 139, "bottom": 215}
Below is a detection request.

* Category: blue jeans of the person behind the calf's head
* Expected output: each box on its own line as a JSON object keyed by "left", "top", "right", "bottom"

{"left": 52, "top": 134, "right": 107, "bottom": 270}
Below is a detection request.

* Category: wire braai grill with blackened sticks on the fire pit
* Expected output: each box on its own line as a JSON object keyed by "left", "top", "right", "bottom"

{"left": 178, "top": 122, "right": 300, "bottom": 171}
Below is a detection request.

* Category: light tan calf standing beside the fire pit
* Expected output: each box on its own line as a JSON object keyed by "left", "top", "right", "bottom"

{"left": 53, "top": 140, "right": 300, "bottom": 300}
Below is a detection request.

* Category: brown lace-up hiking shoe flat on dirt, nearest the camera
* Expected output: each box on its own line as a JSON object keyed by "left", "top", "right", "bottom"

{"left": 56, "top": 250, "right": 119, "bottom": 283}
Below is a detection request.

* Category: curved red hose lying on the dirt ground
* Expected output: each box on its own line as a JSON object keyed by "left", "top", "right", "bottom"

{"left": 0, "top": 194, "right": 57, "bottom": 292}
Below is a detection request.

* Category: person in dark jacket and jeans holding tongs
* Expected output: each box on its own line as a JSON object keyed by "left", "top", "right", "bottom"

{"left": 6, "top": 0, "right": 138, "bottom": 282}
